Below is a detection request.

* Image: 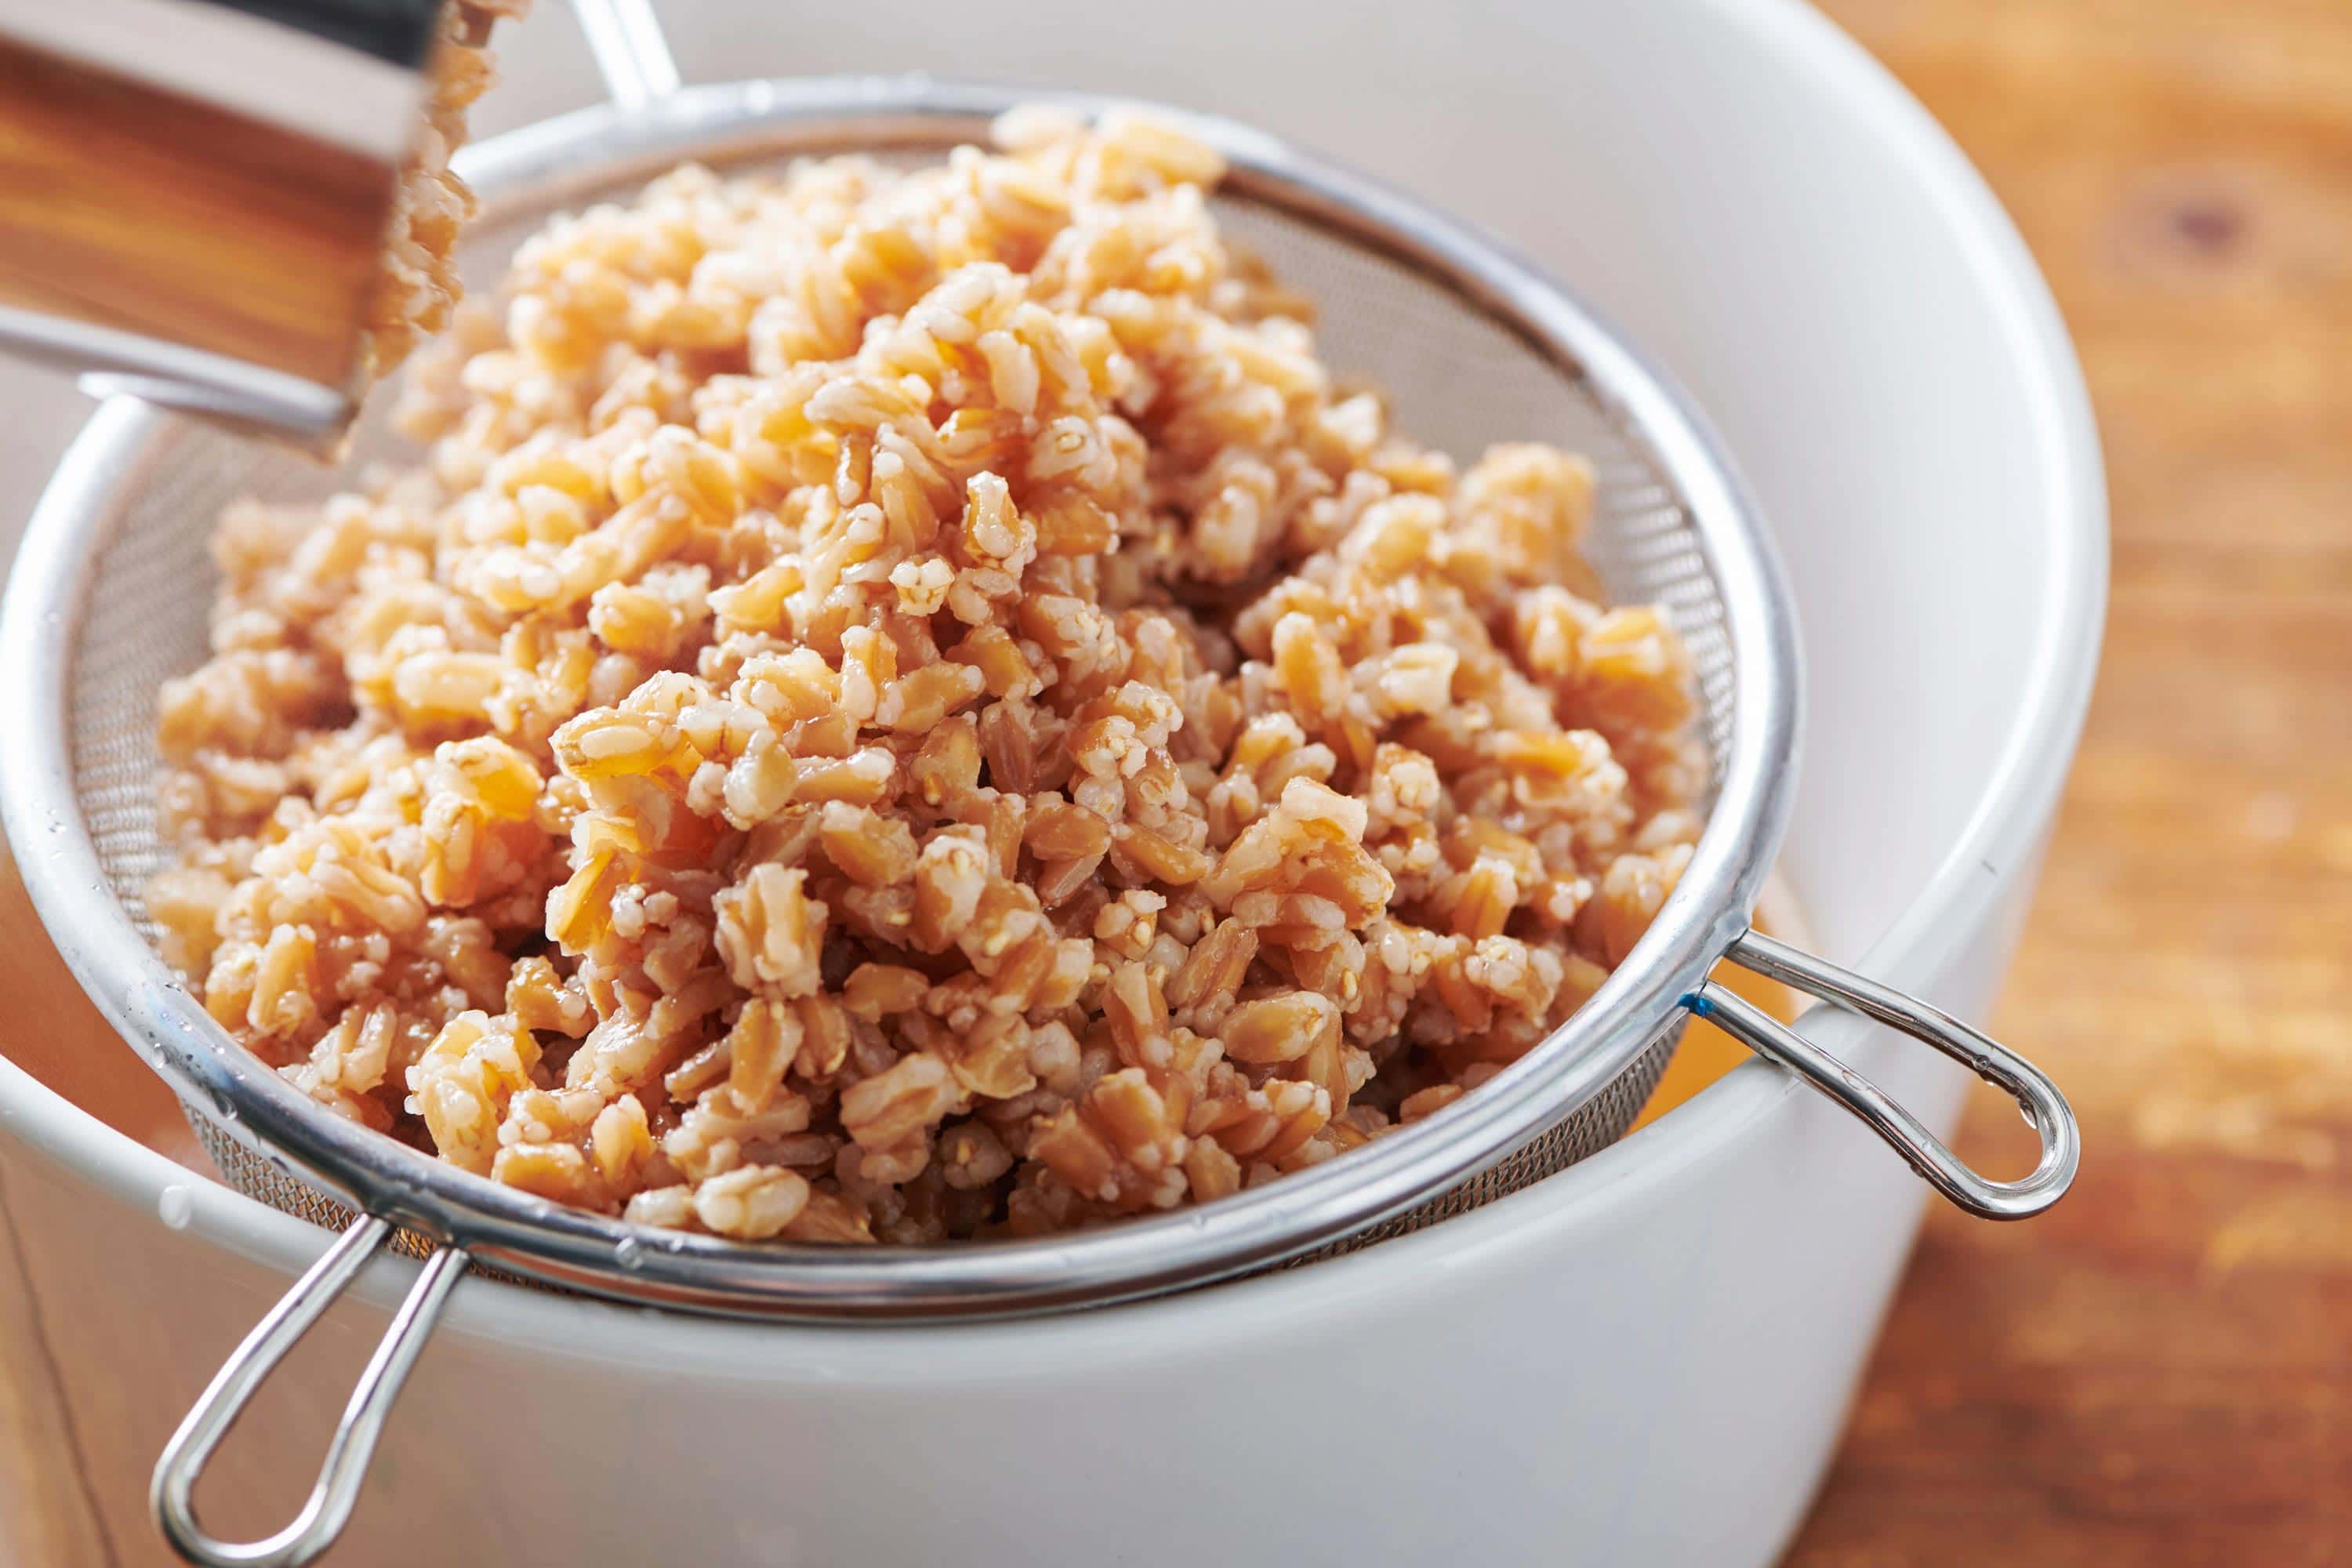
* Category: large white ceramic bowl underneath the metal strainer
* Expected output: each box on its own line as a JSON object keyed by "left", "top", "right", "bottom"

{"left": 0, "top": 0, "right": 2105, "bottom": 1568}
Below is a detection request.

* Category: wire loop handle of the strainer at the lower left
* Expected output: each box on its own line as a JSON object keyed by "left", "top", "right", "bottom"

{"left": 148, "top": 1215, "right": 468, "bottom": 1568}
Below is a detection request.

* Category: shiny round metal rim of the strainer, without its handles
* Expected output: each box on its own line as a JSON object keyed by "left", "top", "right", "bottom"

{"left": 0, "top": 78, "right": 1799, "bottom": 1321}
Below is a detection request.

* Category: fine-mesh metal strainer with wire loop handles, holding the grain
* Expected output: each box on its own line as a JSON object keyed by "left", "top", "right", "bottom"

{"left": 0, "top": 7, "right": 2077, "bottom": 1563}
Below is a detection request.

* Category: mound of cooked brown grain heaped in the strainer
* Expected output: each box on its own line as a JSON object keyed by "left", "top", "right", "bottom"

{"left": 148, "top": 111, "right": 1703, "bottom": 1241}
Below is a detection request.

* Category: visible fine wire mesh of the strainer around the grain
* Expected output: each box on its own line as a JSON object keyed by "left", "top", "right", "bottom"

{"left": 71, "top": 171, "right": 1733, "bottom": 1288}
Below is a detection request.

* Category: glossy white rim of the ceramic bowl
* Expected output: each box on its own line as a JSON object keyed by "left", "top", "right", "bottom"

{"left": 0, "top": 0, "right": 2107, "bottom": 1382}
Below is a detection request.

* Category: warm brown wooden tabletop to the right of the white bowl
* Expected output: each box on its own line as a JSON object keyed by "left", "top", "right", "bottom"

{"left": 1790, "top": 0, "right": 2352, "bottom": 1568}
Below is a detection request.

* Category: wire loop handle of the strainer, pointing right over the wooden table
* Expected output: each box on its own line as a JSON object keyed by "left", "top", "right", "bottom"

{"left": 1684, "top": 931, "right": 2082, "bottom": 1220}
